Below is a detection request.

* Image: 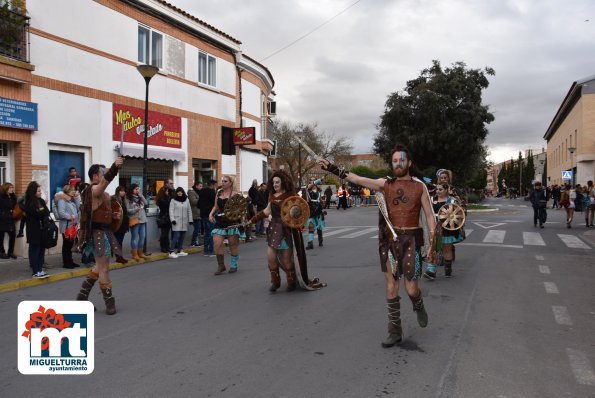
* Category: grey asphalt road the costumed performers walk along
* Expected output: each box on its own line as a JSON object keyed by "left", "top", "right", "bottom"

{"left": 0, "top": 199, "right": 595, "bottom": 398}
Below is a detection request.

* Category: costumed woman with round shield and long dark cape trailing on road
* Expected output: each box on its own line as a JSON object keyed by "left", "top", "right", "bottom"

{"left": 250, "top": 170, "right": 326, "bottom": 292}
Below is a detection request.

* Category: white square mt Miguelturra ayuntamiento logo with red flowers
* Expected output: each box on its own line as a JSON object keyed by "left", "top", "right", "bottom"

{"left": 18, "top": 301, "right": 95, "bottom": 374}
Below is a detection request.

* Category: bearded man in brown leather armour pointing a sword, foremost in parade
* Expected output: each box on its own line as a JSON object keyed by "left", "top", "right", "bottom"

{"left": 318, "top": 145, "right": 436, "bottom": 347}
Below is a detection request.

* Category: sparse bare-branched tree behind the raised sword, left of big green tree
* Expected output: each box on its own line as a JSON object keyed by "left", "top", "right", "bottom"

{"left": 271, "top": 121, "right": 353, "bottom": 184}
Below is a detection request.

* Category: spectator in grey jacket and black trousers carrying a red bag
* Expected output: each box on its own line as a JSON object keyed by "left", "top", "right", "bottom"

{"left": 54, "top": 185, "right": 81, "bottom": 269}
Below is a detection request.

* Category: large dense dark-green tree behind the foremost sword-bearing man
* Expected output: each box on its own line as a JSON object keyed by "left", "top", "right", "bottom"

{"left": 374, "top": 60, "right": 495, "bottom": 185}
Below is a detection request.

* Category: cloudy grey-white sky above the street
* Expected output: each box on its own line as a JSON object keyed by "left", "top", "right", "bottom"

{"left": 169, "top": 0, "right": 595, "bottom": 162}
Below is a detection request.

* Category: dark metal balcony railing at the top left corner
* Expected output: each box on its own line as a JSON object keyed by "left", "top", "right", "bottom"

{"left": 0, "top": 4, "right": 30, "bottom": 62}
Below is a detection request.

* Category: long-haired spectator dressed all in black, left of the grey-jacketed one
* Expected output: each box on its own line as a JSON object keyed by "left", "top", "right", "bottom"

{"left": 25, "top": 181, "right": 50, "bottom": 279}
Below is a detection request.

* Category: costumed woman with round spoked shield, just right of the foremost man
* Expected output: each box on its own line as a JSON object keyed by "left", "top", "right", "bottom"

{"left": 424, "top": 183, "right": 463, "bottom": 280}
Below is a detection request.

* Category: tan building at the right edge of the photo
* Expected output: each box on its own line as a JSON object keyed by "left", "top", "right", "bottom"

{"left": 543, "top": 75, "right": 595, "bottom": 185}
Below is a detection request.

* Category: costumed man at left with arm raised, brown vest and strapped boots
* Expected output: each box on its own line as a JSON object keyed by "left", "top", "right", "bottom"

{"left": 76, "top": 157, "right": 128, "bottom": 315}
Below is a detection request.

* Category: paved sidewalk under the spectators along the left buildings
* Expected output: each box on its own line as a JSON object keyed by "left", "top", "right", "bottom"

{"left": 0, "top": 240, "right": 203, "bottom": 293}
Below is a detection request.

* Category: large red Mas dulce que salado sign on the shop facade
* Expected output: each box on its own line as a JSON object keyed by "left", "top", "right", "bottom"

{"left": 112, "top": 104, "right": 182, "bottom": 149}
